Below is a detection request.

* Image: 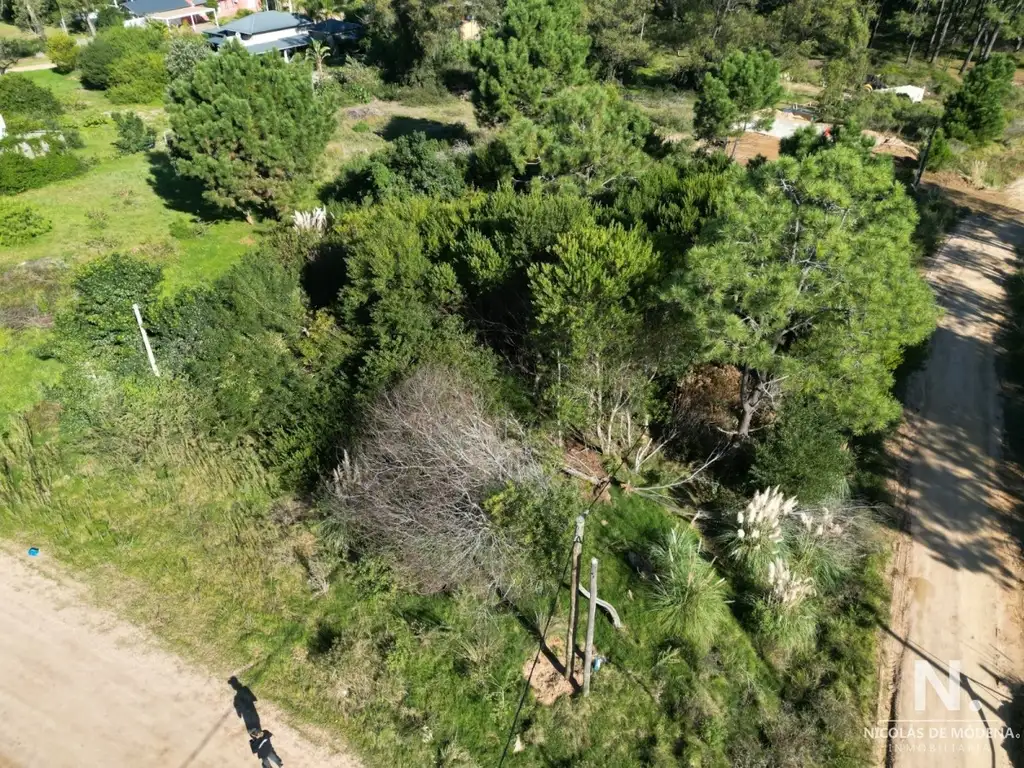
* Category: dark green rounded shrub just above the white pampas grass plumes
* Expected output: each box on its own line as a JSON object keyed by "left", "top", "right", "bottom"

{"left": 752, "top": 398, "right": 853, "bottom": 504}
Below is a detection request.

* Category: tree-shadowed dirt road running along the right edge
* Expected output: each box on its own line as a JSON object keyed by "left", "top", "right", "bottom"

{"left": 888, "top": 212, "right": 1024, "bottom": 768}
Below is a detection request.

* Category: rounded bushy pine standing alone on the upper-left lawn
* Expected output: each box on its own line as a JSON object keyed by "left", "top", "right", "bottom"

{"left": 168, "top": 46, "right": 334, "bottom": 220}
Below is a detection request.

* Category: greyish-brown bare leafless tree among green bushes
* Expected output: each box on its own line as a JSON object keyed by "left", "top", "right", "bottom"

{"left": 331, "top": 367, "right": 544, "bottom": 592}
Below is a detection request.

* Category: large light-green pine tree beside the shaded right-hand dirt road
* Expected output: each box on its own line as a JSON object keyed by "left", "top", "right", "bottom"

{"left": 667, "top": 145, "right": 936, "bottom": 435}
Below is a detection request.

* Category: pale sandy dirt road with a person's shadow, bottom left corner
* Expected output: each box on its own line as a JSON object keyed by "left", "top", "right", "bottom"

{"left": 0, "top": 551, "right": 359, "bottom": 768}
